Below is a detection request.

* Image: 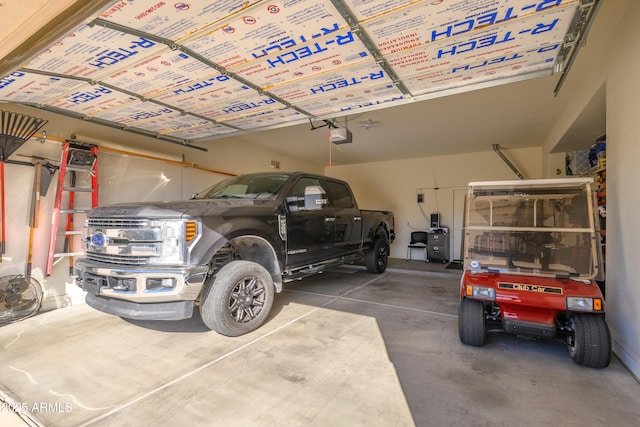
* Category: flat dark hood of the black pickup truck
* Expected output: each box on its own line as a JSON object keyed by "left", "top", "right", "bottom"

{"left": 88, "top": 199, "right": 276, "bottom": 218}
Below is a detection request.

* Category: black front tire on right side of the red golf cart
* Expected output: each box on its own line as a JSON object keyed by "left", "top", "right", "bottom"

{"left": 567, "top": 314, "right": 611, "bottom": 369}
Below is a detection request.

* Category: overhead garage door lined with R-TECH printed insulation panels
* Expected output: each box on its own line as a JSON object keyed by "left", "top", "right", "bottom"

{"left": 0, "top": 0, "right": 594, "bottom": 150}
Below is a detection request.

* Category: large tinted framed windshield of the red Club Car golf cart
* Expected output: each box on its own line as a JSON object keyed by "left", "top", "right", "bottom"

{"left": 464, "top": 178, "right": 598, "bottom": 279}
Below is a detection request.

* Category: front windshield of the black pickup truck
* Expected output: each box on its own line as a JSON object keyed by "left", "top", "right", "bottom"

{"left": 193, "top": 174, "right": 289, "bottom": 200}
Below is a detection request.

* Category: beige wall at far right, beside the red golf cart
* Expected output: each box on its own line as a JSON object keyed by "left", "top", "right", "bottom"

{"left": 604, "top": 1, "right": 640, "bottom": 378}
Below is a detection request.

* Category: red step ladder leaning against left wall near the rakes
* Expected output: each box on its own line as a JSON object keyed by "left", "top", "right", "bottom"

{"left": 46, "top": 140, "right": 98, "bottom": 276}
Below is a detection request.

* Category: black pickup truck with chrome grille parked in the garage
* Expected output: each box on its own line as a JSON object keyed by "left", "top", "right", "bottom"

{"left": 74, "top": 172, "right": 395, "bottom": 336}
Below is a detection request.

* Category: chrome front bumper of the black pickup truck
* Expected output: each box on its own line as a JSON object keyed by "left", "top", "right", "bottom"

{"left": 75, "top": 258, "right": 208, "bottom": 320}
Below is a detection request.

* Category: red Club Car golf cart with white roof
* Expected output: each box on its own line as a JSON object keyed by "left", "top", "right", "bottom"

{"left": 459, "top": 178, "right": 611, "bottom": 368}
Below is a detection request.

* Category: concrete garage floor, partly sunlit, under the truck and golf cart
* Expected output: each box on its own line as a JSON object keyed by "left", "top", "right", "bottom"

{"left": 0, "top": 260, "right": 640, "bottom": 427}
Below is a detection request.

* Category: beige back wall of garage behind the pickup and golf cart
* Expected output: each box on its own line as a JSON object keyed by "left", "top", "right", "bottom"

{"left": 325, "top": 147, "right": 543, "bottom": 259}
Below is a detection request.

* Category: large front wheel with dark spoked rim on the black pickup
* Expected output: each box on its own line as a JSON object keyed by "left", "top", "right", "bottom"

{"left": 200, "top": 261, "right": 275, "bottom": 337}
